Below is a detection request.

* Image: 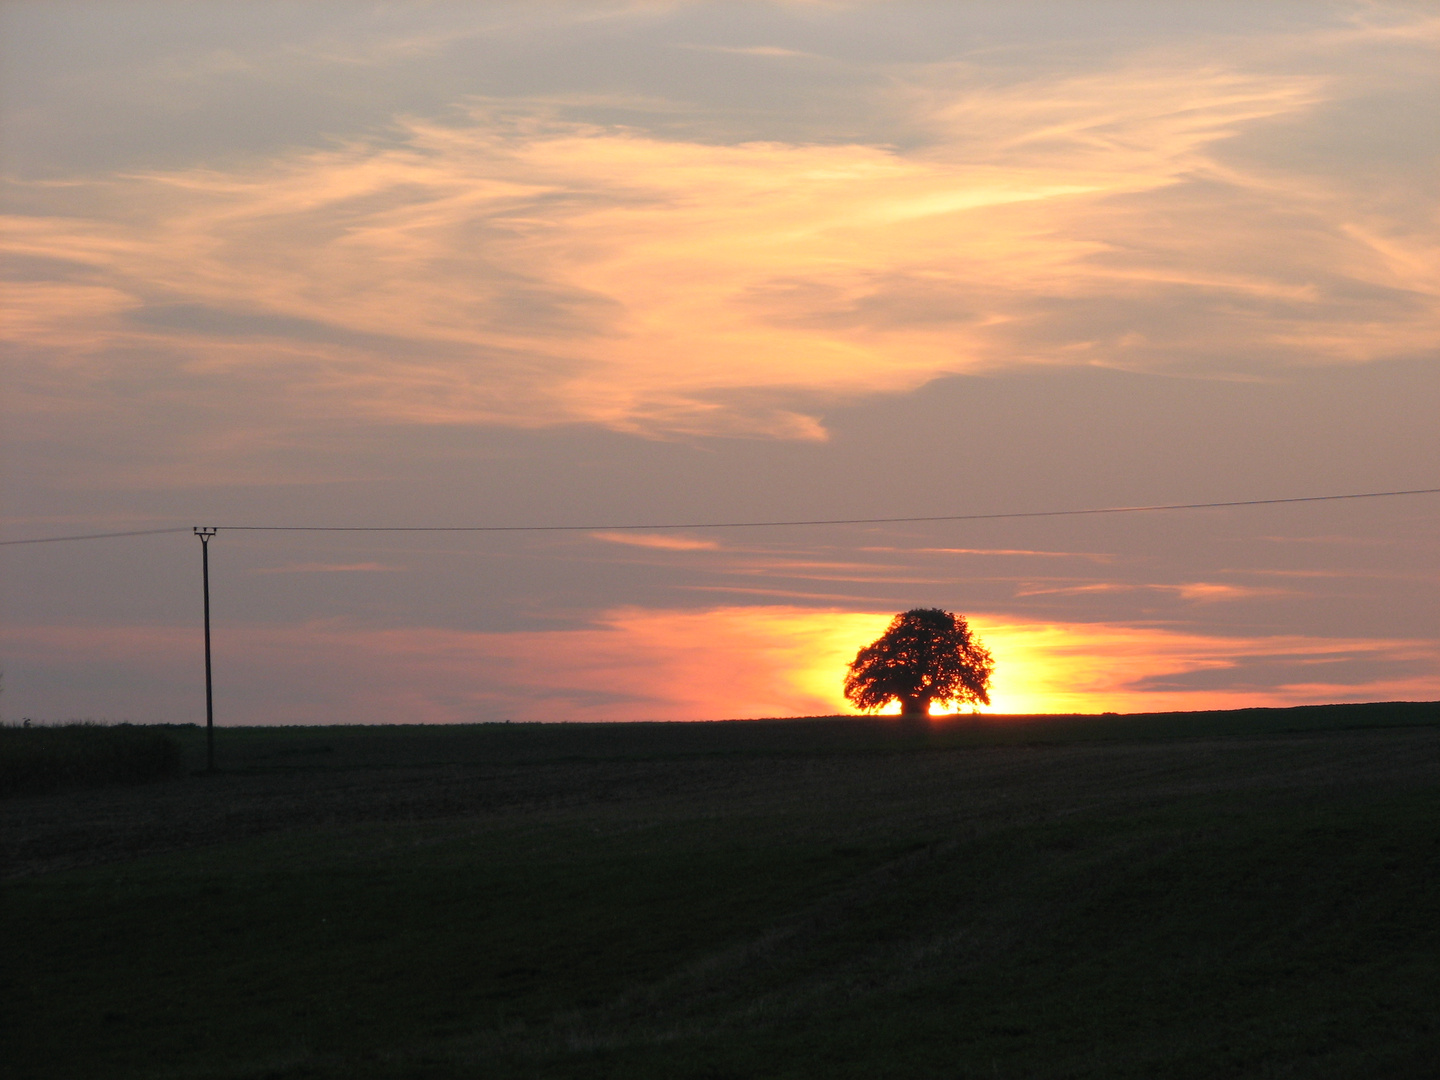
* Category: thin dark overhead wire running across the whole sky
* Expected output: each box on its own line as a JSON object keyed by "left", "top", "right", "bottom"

{"left": 0, "top": 488, "right": 1440, "bottom": 546}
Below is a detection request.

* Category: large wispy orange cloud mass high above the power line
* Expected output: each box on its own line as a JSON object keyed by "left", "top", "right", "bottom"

{"left": 4, "top": 44, "right": 1440, "bottom": 452}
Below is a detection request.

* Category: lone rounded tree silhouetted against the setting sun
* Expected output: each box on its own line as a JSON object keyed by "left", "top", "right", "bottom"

{"left": 845, "top": 608, "right": 995, "bottom": 717}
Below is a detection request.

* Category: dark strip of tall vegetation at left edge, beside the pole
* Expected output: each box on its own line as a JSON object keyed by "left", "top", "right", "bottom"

{"left": 0, "top": 723, "right": 180, "bottom": 798}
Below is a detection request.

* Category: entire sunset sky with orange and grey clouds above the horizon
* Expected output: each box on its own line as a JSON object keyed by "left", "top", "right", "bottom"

{"left": 0, "top": 0, "right": 1440, "bottom": 724}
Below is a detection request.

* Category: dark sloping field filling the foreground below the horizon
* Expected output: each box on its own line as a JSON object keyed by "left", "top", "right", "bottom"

{"left": 0, "top": 704, "right": 1440, "bottom": 1080}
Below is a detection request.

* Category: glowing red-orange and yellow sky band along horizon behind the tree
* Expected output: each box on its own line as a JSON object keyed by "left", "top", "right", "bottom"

{"left": 8, "top": 606, "right": 1440, "bottom": 724}
